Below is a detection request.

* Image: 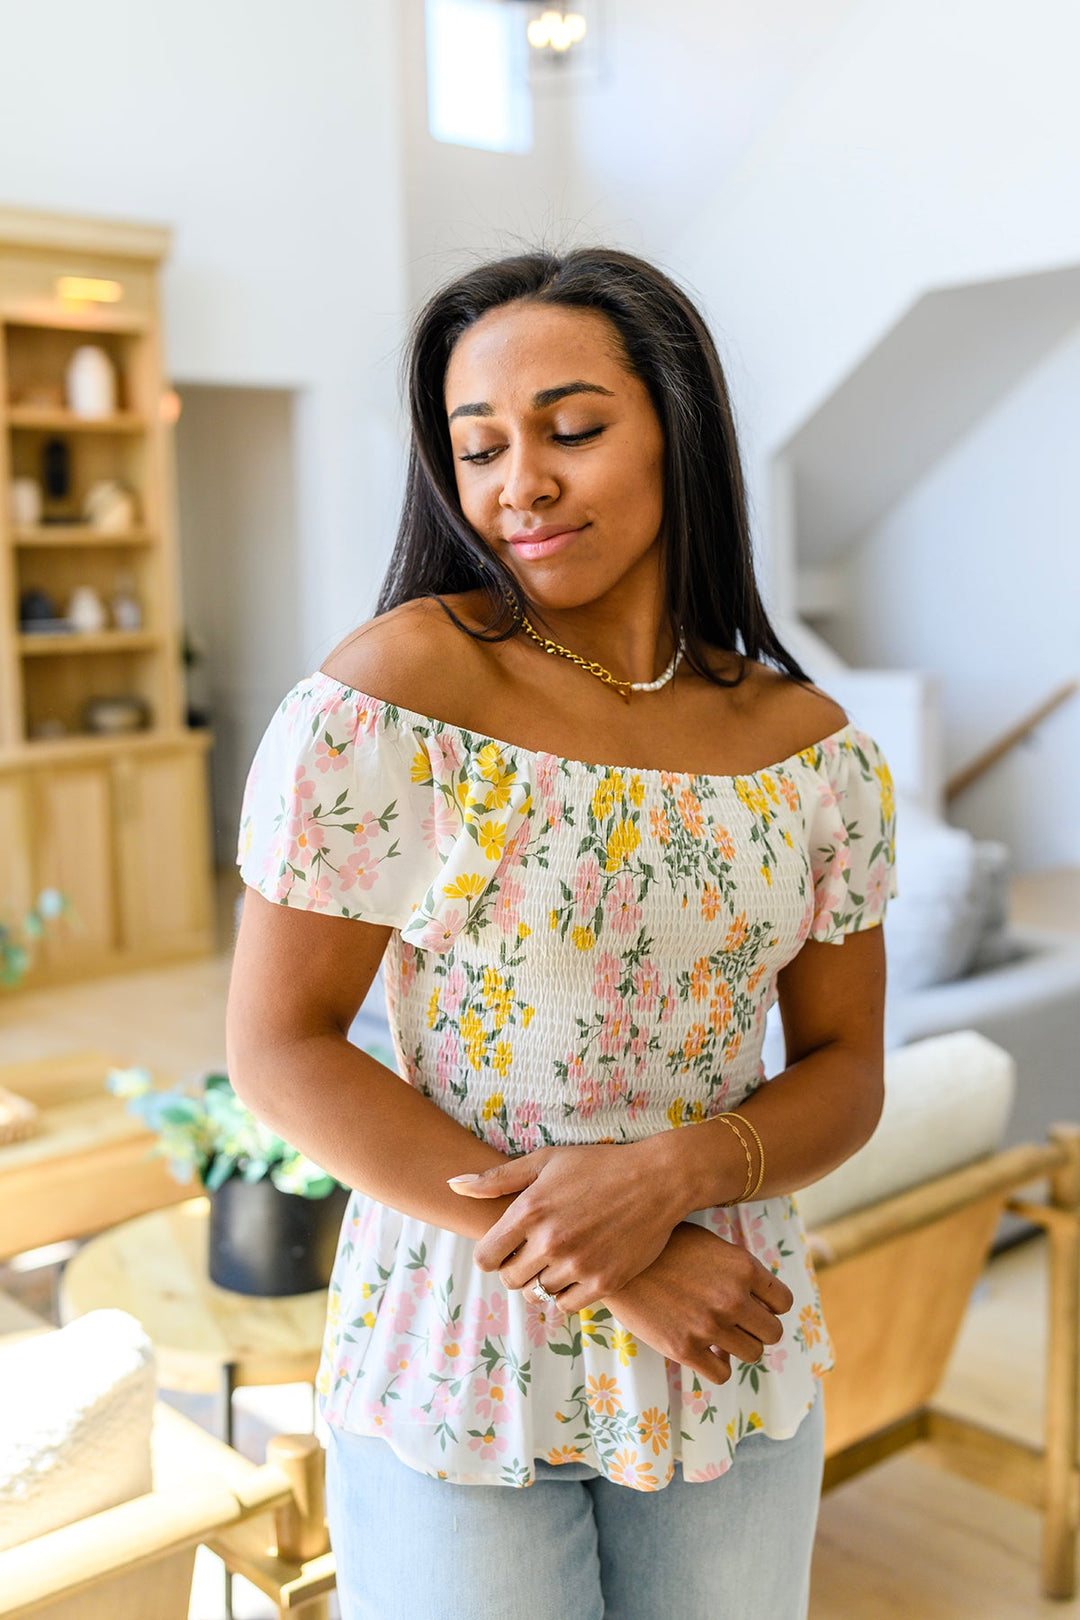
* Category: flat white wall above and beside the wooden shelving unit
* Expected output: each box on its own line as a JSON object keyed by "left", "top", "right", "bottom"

{"left": 0, "top": 0, "right": 405, "bottom": 667}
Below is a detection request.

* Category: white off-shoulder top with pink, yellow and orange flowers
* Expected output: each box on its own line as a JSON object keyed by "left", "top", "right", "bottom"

{"left": 238, "top": 671, "right": 895, "bottom": 1490}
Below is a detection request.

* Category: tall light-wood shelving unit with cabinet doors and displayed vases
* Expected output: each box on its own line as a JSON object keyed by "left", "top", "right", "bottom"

{"left": 0, "top": 209, "right": 214, "bottom": 987}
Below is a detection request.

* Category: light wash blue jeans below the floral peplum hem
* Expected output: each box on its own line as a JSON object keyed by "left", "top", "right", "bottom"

{"left": 327, "top": 1395, "right": 824, "bottom": 1620}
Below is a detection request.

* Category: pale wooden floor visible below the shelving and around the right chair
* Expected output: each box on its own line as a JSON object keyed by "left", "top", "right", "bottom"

{"left": 0, "top": 872, "right": 1080, "bottom": 1620}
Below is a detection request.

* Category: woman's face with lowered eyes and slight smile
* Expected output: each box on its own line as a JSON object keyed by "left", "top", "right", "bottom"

{"left": 445, "top": 303, "right": 664, "bottom": 609}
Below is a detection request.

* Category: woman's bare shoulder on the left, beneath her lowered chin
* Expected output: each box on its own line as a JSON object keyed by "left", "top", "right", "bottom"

{"left": 321, "top": 593, "right": 505, "bottom": 718}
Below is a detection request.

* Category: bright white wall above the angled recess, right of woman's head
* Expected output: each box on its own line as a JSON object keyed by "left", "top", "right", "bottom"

{"left": 670, "top": 0, "right": 1080, "bottom": 601}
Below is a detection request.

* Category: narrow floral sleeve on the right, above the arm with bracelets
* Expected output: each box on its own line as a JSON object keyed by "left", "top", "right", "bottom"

{"left": 808, "top": 726, "right": 897, "bottom": 944}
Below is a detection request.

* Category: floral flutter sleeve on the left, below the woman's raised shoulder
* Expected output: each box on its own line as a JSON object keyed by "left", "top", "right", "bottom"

{"left": 236, "top": 671, "right": 533, "bottom": 953}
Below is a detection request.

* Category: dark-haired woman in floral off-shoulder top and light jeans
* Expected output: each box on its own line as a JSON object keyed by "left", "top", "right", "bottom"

{"left": 228, "top": 249, "right": 894, "bottom": 1620}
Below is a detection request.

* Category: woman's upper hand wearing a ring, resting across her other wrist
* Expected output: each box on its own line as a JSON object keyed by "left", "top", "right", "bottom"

{"left": 450, "top": 1137, "right": 688, "bottom": 1312}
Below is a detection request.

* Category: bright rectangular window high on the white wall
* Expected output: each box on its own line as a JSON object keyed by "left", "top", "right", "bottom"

{"left": 426, "top": 0, "right": 533, "bottom": 152}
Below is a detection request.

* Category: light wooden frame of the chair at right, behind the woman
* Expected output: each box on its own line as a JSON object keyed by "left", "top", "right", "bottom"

{"left": 810, "top": 1126, "right": 1080, "bottom": 1599}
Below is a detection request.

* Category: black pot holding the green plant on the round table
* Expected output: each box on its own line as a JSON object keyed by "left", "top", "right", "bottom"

{"left": 209, "top": 1176, "right": 348, "bottom": 1298}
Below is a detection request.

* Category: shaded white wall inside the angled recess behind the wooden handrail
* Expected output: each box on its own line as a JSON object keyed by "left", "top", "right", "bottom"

{"left": 829, "top": 327, "right": 1080, "bottom": 870}
